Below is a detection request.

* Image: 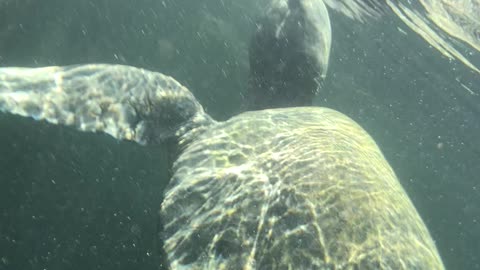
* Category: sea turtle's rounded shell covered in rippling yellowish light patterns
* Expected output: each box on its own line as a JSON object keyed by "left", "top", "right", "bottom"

{"left": 160, "top": 107, "right": 444, "bottom": 269}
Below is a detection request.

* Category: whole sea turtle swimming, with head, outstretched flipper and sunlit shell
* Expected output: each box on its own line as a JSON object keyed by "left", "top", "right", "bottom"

{"left": 0, "top": 0, "right": 444, "bottom": 269}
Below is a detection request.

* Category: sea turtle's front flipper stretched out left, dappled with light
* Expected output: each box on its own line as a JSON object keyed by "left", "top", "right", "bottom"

{"left": 0, "top": 64, "right": 213, "bottom": 144}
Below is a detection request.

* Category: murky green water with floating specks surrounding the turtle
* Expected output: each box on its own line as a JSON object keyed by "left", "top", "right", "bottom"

{"left": 0, "top": 0, "right": 480, "bottom": 270}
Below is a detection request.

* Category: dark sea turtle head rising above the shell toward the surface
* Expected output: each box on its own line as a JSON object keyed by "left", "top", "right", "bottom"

{"left": 246, "top": 0, "right": 331, "bottom": 110}
